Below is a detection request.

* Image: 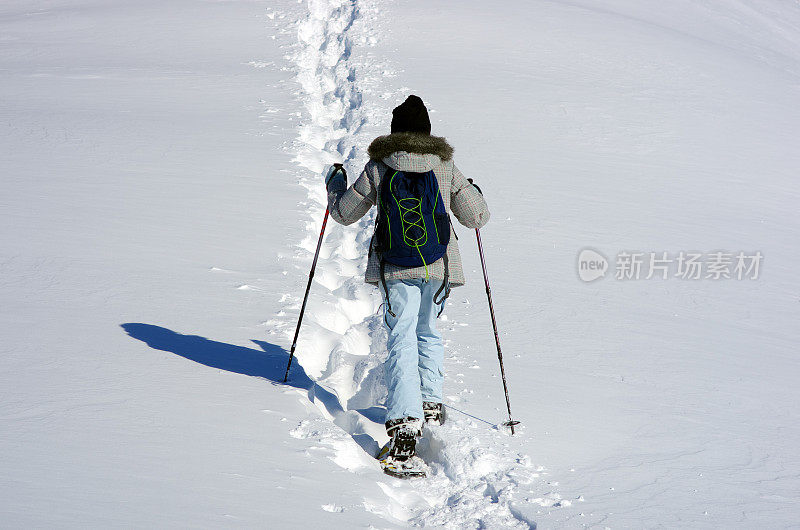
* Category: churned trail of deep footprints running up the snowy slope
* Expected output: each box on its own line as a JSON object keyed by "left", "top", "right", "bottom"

{"left": 274, "top": 0, "right": 560, "bottom": 528}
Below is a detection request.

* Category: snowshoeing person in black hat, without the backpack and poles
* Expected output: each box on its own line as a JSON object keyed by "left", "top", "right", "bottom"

{"left": 324, "top": 95, "right": 489, "bottom": 459}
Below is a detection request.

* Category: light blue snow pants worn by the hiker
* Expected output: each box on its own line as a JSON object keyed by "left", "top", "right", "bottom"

{"left": 384, "top": 279, "right": 444, "bottom": 421}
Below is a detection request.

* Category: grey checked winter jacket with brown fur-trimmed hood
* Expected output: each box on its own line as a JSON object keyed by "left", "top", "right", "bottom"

{"left": 328, "top": 133, "right": 489, "bottom": 287}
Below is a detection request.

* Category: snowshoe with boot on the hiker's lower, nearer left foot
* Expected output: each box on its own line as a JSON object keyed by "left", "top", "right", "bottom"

{"left": 378, "top": 418, "right": 427, "bottom": 478}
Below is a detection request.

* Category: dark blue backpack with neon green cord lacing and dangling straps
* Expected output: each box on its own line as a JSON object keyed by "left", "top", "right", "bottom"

{"left": 375, "top": 168, "right": 450, "bottom": 316}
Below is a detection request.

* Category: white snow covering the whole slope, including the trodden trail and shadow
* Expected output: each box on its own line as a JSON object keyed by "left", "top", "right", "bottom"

{"left": 0, "top": 0, "right": 800, "bottom": 528}
